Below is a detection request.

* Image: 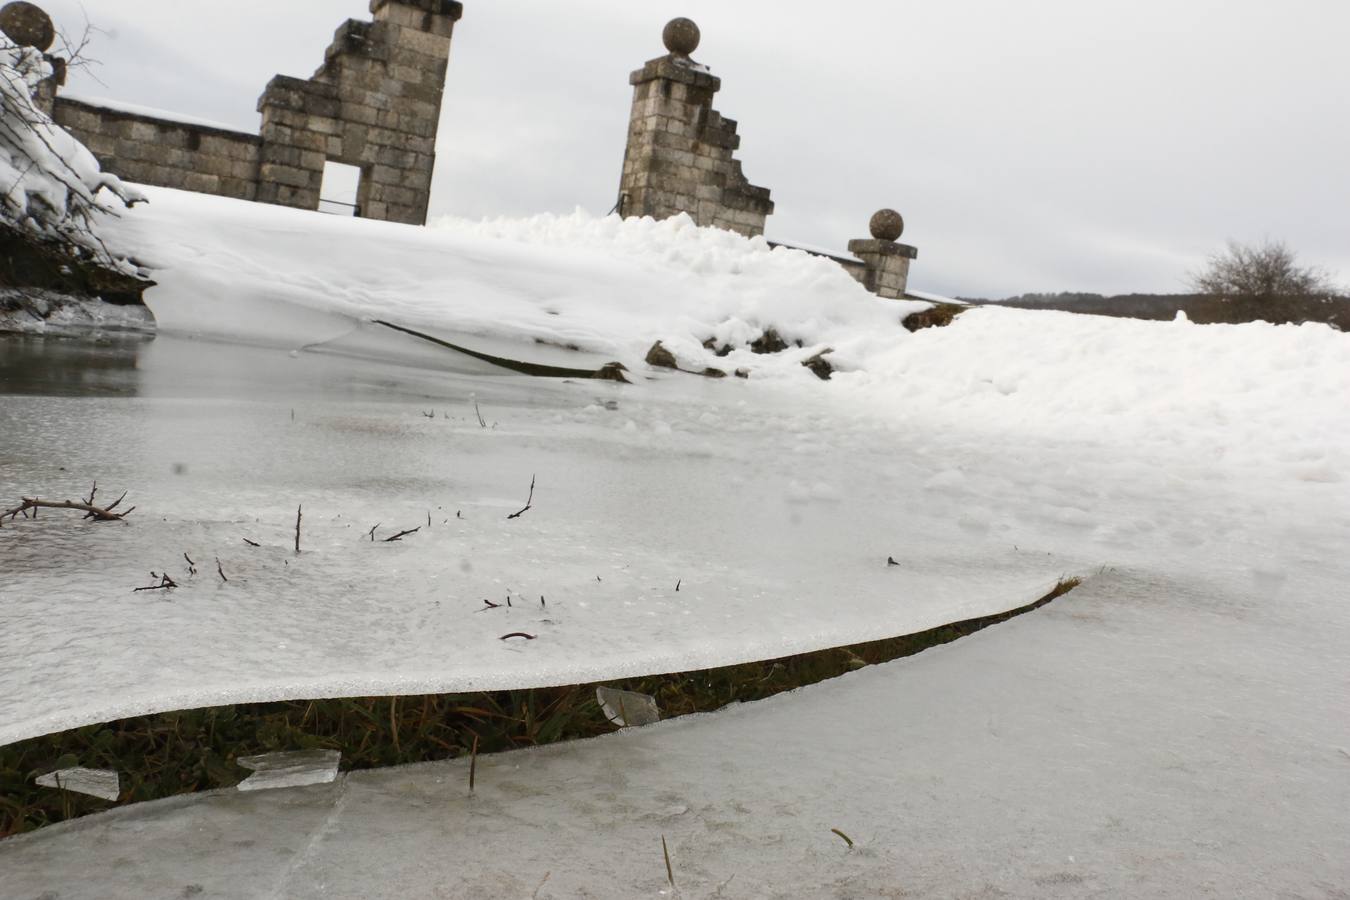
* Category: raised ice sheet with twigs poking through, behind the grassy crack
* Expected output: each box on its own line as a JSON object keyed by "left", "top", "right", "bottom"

{"left": 0, "top": 337, "right": 1085, "bottom": 743}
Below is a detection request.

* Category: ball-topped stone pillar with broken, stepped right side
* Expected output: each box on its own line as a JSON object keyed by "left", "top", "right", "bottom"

{"left": 618, "top": 19, "right": 774, "bottom": 236}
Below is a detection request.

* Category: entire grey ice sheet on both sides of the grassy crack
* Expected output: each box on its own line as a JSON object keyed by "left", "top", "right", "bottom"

{"left": 0, "top": 327, "right": 1350, "bottom": 900}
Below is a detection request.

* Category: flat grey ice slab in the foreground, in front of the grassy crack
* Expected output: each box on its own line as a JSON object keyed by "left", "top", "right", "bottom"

{"left": 0, "top": 565, "right": 1350, "bottom": 900}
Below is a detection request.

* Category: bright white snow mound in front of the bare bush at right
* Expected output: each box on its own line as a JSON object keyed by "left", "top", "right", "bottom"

{"left": 837, "top": 308, "right": 1350, "bottom": 482}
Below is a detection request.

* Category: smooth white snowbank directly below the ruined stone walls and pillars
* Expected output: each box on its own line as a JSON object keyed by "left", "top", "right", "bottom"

{"left": 99, "top": 189, "right": 926, "bottom": 379}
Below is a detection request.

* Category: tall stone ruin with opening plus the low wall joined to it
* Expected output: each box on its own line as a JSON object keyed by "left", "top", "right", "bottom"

{"left": 42, "top": 0, "right": 463, "bottom": 225}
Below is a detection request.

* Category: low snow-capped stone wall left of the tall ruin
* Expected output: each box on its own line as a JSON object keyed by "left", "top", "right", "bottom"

{"left": 53, "top": 96, "right": 262, "bottom": 200}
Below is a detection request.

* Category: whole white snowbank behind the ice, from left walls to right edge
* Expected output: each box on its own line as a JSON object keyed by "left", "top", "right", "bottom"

{"left": 109, "top": 189, "right": 1350, "bottom": 480}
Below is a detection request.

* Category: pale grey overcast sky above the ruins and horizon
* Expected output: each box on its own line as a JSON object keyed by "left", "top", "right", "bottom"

{"left": 41, "top": 0, "right": 1350, "bottom": 297}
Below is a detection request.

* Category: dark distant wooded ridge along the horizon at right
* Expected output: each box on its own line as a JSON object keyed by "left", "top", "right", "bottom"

{"left": 961, "top": 291, "right": 1350, "bottom": 331}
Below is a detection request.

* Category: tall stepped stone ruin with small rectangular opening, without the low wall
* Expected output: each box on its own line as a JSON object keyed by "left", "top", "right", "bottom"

{"left": 258, "top": 0, "right": 463, "bottom": 225}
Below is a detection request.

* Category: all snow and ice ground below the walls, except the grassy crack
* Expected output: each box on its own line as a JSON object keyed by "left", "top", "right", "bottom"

{"left": 0, "top": 183, "right": 1350, "bottom": 897}
